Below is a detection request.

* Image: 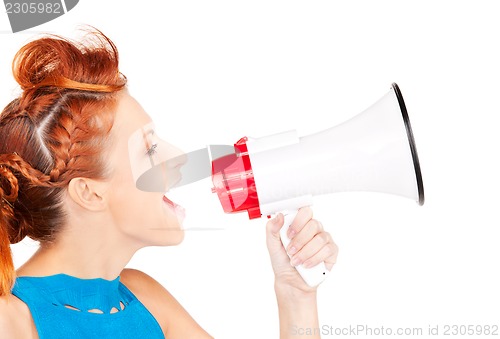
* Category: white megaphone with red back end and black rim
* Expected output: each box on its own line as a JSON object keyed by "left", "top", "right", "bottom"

{"left": 212, "top": 83, "right": 424, "bottom": 286}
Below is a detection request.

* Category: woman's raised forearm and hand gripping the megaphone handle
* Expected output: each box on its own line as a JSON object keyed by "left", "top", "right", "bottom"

{"left": 267, "top": 207, "right": 338, "bottom": 339}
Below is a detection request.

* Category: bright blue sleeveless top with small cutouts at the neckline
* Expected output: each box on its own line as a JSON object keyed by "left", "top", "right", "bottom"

{"left": 12, "top": 274, "right": 165, "bottom": 339}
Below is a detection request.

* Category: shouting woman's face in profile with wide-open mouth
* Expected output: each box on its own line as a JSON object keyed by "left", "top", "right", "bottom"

{"left": 108, "top": 93, "right": 184, "bottom": 246}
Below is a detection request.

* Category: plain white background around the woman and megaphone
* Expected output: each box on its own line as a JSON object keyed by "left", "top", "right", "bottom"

{"left": 0, "top": 0, "right": 500, "bottom": 338}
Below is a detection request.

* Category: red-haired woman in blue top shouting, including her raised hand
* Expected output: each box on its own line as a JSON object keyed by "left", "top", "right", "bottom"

{"left": 0, "top": 31, "right": 337, "bottom": 338}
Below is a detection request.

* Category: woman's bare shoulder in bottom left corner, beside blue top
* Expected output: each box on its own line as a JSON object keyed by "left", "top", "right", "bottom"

{"left": 0, "top": 294, "right": 38, "bottom": 338}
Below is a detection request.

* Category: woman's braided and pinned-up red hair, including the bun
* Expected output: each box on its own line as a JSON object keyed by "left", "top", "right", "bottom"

{"left": 0, "top": 30, "right": 126, "bottom": 296}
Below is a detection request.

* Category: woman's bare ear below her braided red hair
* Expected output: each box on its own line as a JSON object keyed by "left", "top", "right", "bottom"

{"left": 68, "top": 178, "right": 107, "bottom": 211}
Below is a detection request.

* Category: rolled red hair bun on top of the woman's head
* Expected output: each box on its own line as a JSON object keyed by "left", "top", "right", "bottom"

{"left": 12, "top": 30, "right": 126, "bottom": 92}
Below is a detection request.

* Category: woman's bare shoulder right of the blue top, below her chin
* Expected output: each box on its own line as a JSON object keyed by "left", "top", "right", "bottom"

{"left": 120, "top": 269, "right": 212, "bottom": 339}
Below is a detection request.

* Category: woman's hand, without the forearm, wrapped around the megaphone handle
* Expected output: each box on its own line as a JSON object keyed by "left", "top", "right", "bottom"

{"left": 266, "top": 207, "right": 338, "bottom": 292}
